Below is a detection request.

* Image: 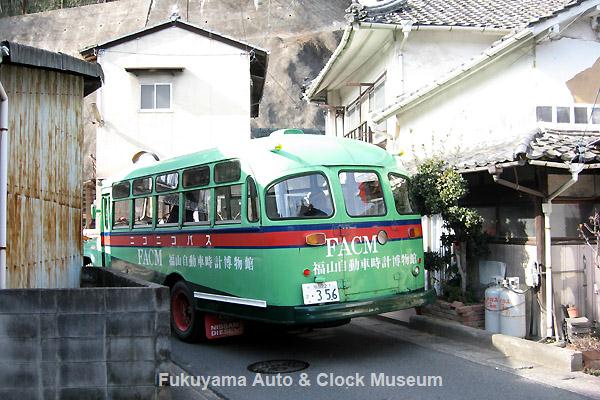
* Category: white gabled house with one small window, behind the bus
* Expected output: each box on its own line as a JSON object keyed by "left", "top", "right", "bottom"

{"left": 81, "top": 16, "right": 268, "bottom": 184}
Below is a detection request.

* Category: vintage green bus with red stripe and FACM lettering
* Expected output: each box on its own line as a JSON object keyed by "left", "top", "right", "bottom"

{"left": 85, "top": 129, "right": 434, "bottom": 340}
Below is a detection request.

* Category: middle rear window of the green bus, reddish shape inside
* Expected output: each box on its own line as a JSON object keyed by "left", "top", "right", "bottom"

{"left": 339, "top": 171, "right": 386, "bottom": 217}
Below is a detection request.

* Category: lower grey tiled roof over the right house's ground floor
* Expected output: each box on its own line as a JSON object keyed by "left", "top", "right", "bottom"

{"left": 449, "top": 129, "right": 600, "bottom": 170}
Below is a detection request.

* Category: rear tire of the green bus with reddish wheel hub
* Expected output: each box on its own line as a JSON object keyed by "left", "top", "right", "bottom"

{"left": 171, "top": 280, "right": 206, "bottom": 342}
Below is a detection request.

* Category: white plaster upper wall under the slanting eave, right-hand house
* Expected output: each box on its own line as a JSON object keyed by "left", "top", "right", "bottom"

{"left": 390, "top": 21, "right": 600, "bottom": 161}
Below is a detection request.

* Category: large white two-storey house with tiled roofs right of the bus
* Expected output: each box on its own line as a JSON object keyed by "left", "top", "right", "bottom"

{"left": 305, "top": 0, "right": 600, "bottom": 336}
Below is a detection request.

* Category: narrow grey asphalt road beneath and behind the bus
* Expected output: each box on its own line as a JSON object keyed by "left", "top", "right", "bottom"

{"left": 172, "top": 318, "right": 596, "bottom": 400}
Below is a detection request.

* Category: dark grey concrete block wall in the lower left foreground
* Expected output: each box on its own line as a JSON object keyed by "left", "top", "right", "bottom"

{"left": 0, "top": 268, "right": 170, "bottom": 400}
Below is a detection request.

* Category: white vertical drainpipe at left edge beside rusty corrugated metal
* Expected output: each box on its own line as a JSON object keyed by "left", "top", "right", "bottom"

{"left": 0, "top": 46, "right": 8, "bottom": 289}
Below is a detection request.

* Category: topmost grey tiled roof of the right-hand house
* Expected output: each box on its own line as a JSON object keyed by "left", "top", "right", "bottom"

{"left": 356, "top": 0, "right": 583, "bottom": 29}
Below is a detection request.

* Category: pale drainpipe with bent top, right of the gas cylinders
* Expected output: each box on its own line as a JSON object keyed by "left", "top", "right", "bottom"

{"left": 542, "top": 163, "right": 584, "bottom": 338}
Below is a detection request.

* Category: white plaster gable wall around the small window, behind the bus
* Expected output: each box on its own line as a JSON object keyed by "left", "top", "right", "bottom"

{"left": 97, "top": 27, "right": 250, "bottom": 178}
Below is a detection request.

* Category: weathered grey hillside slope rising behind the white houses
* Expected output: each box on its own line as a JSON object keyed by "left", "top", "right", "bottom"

{"left": 0, "top": 0, "right": 347, "bottom": 227}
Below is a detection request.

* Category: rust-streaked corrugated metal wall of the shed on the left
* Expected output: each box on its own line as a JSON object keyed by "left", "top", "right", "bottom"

{"left": 0, "top": 64, "right": 83, "bottom": 288}
